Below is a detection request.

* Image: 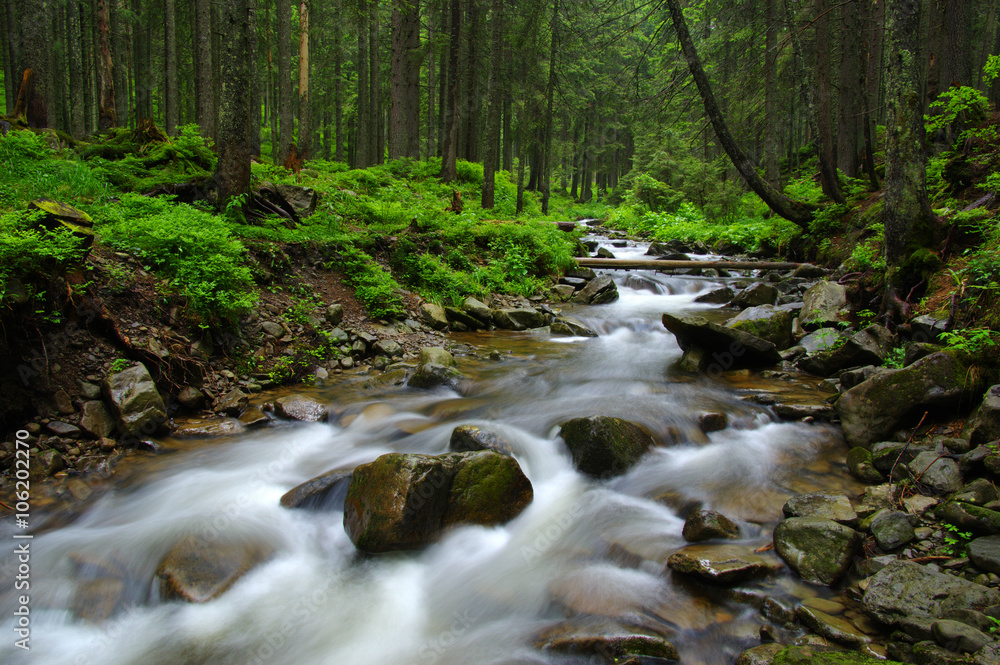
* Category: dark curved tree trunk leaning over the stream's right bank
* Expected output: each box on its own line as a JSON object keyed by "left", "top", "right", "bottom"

{"left": 667, "top": 0, "right": 813, "bottom": 228}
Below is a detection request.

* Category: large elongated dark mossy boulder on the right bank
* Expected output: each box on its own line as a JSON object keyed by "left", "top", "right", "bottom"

{"left": 835, "top": 353, "right": 971, "bottom": 447}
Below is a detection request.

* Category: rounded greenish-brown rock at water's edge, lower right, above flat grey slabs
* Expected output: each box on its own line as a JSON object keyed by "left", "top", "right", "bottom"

{"left": 774, "top": 517, "right": 861, "bottom": 586}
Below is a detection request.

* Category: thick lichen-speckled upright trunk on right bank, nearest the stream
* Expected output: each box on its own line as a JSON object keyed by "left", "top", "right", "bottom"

{"left": 882, "top": 0, "right": 931, "bottom": 264}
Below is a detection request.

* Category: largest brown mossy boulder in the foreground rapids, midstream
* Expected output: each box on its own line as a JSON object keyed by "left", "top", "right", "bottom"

{"left": 344, "top": 451, "right": 533, "bottom": 552}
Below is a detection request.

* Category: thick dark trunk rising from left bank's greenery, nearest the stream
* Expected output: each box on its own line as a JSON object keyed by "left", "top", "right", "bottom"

{"left": 214, "top": 0, "right": 254, "bottom": 208}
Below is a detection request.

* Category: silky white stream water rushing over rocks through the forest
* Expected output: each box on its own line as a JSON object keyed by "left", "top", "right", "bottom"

{"left": 0, "top": 236, "right": 849, "bottom": 665}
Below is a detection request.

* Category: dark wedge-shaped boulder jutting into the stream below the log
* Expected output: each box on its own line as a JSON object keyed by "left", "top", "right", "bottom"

{"left": 663, "top": 314, "right": 781, "bottom": 372}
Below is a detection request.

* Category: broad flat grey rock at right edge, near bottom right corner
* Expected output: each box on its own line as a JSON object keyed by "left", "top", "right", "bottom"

{"left": 862, "top": 561, "right": 1000, "bottom": 624}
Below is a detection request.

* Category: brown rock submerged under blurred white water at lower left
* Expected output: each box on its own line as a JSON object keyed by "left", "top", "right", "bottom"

{"left": 156, "top": 536, "right": 272, "bottom": 603}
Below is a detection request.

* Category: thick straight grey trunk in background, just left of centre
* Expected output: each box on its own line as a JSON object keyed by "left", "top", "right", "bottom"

{"left": 389, "top": 0, "right": 420, "bottom": 159}
